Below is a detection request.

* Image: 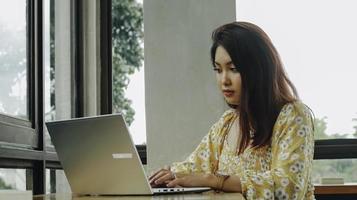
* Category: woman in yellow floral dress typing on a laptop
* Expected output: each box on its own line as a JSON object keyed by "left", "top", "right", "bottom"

{"left": 149, "top": 22, "right": 314, "bottom": 199}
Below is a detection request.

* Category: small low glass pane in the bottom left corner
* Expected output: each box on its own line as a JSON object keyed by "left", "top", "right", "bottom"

{"left": 0, "top": 168, "right": 26, "bottom": 191}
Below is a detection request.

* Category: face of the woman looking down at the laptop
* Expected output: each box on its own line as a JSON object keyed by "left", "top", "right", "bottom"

{"left": 214, "top": 46, "right": 242, "bottom": 105}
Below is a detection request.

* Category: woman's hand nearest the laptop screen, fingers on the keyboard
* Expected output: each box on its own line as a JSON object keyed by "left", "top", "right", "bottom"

{"left": 149, "top": 166, "right": 175, "bottom": 187}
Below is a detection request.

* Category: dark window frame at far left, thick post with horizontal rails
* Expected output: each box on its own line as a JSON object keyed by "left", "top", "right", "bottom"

{"left": 0, "top": 0, "right": 46, "bottom": 194}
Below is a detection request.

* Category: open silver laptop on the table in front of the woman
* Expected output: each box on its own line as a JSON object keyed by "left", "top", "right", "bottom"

{"left": 46, "top": 114, "right": 210, "bottom": 195}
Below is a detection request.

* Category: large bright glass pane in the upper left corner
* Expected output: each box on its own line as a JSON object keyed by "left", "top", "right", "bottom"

{"left": 0, "top": 0, "right": 28, "bottom": 119}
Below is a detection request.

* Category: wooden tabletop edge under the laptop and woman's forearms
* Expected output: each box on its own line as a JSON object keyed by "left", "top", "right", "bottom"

{"left": 32, "top": 191, "right": 244, "bottom": 200}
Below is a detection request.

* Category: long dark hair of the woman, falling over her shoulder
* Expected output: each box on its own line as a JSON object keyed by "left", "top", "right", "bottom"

{"left": 211, "top": 22, "right": 299, "bottom": 154}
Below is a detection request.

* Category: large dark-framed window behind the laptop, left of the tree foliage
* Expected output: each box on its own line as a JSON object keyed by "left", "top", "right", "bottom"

{"left": 0, "top": 0, "right": 121, "bottom": 194}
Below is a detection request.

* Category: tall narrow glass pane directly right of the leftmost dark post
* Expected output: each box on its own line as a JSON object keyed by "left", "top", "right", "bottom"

{"left": 43, "top": 0, "right": 73, "bottom": 151}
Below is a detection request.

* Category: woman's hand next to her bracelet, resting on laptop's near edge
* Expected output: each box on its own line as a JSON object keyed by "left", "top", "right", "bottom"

{"left": 167, "top": 174, "right": 217, "bottom": 187}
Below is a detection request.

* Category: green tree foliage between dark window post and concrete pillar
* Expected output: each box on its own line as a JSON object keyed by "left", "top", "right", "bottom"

{"left": 112, "top": 0, "right": 143, "bottom": 125}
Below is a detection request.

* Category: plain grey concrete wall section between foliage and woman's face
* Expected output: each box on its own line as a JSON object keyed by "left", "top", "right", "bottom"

{"left": 144, "top": 0, "right": 236, "bottom": 171}
